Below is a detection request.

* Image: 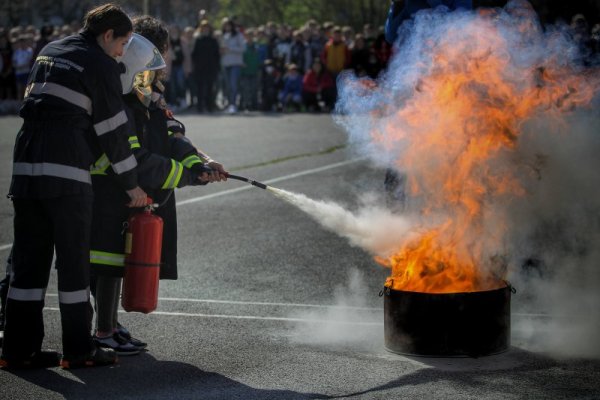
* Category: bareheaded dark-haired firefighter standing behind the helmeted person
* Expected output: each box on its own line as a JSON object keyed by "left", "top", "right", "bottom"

{"left": 0, "top": 3, "right": 146, "bottom": 369}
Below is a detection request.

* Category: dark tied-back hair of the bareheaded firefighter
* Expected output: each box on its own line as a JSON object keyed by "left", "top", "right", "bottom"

{"left": 83, "top": 3, "right": 133, "bottom": 37}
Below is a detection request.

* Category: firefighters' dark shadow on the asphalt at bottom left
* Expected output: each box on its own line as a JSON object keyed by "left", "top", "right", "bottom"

{"left": 7, "top": 353, "right": 330, "bottom": 400}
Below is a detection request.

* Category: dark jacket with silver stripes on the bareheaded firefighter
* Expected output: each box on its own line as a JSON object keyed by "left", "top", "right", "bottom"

{"left": 10, "top": 33, "right": 137, "bottom": 198}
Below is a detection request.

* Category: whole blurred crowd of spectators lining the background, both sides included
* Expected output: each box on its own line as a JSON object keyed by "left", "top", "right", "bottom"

{"left": 0, "top": 14, "right": 600, "bottom": 114}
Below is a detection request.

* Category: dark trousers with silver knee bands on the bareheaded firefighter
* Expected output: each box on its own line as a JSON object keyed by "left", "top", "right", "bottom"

{"left": 2, "top": 195, "right": 93, "bottom": 359}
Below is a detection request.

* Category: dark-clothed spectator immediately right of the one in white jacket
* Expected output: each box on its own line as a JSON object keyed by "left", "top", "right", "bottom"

{"left": 240, "top": 29, "right": 261, "bottom": 111}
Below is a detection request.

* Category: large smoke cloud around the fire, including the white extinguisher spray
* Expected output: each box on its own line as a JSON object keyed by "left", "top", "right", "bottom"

{"left": 279, "top": 0, "right": 600, "bottom": 357}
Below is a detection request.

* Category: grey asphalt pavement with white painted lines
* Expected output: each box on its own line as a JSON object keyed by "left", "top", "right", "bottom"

{"left": 0, "top": 113, "right": 600, "bottom": 400}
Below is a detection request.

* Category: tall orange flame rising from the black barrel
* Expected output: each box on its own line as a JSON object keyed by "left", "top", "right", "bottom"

{"left": 371, "top": 6, "right": 598, "bottom": 293}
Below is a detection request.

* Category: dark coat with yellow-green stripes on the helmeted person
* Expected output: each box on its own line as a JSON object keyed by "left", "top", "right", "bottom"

{"left": 90, "top": 94, "right": 204, "bottom": 279}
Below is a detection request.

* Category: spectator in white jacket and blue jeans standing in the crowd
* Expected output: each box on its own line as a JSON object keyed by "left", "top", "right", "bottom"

{"left": 221, "top": 18, "right": 246, "bottom": 114}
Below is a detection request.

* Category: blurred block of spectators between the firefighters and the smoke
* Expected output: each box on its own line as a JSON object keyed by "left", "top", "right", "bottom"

{"left": 166, "top": 18, "right": 391, "bottom": 113}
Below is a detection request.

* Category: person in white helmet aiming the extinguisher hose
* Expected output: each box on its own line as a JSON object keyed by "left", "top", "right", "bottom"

{"left": 90, "top": 16, "right": 227, "bottom": 355}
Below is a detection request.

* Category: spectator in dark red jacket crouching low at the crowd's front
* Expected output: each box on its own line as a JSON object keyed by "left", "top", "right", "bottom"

{"left": 302, "top": 59, "right": 335, "bottom": 111}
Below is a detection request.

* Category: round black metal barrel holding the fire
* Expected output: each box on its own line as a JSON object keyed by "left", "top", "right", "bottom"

{"left": 383, "top": 286, "right": 512, "bottom": 357}
